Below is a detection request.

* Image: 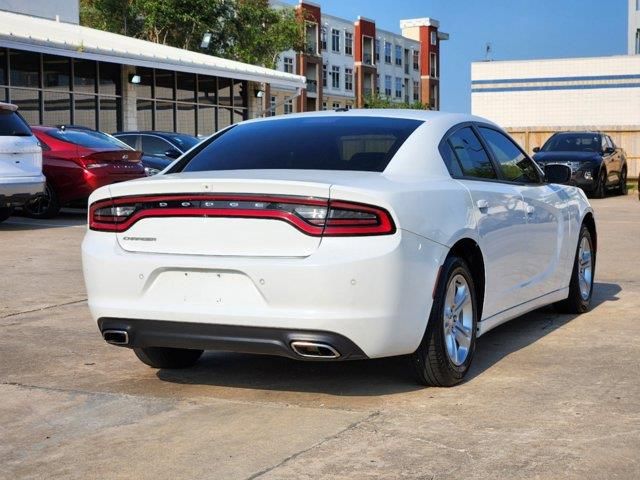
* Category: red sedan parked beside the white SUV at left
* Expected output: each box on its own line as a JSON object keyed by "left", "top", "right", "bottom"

{"left": 23, "top": 126, "right": 145, "bottom": 218}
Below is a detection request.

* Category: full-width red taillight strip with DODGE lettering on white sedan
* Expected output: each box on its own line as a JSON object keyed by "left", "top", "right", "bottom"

{"left": 89, "top": 194, "right": 396, "bottom": 236}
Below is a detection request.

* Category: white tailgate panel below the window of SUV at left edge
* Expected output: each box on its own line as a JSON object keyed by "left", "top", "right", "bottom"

{"left": 0, "top": 136, "right": 42, "bottom": 177}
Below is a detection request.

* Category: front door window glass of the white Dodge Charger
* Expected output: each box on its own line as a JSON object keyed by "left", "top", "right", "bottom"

{"left": 479, "top": 127, "right": 540, "bottom": 183}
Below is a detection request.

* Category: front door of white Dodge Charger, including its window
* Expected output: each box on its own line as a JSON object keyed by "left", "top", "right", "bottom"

{"left": 478, "top": 125, "right": 574, "bottom": 301}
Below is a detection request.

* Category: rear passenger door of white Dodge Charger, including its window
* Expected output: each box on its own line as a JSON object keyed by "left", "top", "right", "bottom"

{"left": 441, "top": 124, "right": 527, "bottom": 318}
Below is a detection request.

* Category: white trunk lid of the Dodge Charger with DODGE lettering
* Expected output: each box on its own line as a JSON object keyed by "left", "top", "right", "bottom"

{"left": 110, "top": 171, "right": 340, "bottom": 257}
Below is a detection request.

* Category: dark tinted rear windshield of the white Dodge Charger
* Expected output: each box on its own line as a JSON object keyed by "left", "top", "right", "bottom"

{"left": 182, "top": 116, "right": 422, "bottom": 172}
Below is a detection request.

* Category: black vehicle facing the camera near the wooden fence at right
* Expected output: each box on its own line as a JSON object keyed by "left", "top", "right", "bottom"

{"left": 533, "top": 132, "right": 627, "bottom": 198}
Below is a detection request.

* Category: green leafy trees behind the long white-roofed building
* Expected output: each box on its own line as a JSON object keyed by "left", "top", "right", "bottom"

{"left": 80, "top": 0, "right": 304, "bottom": 67}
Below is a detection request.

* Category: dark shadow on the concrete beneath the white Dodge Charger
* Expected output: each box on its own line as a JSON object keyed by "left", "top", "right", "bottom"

{"left": 157, "top": 283, "right": 621, "bottom": 397}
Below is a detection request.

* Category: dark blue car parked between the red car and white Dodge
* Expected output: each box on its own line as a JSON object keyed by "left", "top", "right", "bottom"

{"left": 113, "top": 131, "right": 200, "bottom": 175}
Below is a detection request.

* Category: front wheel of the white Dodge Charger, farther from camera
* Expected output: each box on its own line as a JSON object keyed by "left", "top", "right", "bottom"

{"left": 554, "top": 224, "right": 596, "bottom": 314}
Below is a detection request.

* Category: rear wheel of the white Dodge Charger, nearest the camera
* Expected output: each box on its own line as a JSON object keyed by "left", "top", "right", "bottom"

{"left": 411, "top": 257, "right": 478, "bottom": 387}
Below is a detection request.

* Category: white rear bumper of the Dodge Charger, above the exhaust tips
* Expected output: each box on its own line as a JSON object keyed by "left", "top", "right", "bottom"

{"left": 82, "top": 230, "right": 448, "bottom": 358}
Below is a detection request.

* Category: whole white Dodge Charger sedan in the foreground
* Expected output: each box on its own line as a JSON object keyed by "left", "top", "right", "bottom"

{"left": 82, "top": 110, "right": 596, "bottom": 386}
